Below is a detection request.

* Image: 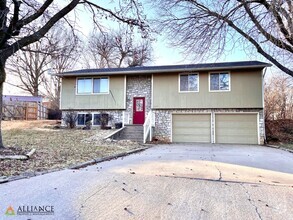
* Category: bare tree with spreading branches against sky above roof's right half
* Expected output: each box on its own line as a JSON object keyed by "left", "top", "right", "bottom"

{"left": 154, "top": 0, "right": 293, "bottom": 76}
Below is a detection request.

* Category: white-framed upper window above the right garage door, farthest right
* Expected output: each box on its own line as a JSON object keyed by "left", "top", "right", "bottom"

{"left": 210, "top": 72, "right": 230, "bottom": 91}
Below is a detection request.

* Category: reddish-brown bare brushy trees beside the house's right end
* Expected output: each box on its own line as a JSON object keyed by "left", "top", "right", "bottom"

{"left": 264, "top": 75, "right": 293, "bottom": 120}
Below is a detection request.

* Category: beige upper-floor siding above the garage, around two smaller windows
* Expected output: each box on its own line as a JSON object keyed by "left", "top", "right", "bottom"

{"left": 153, "top": 70, "right": 263, "bottom": 109}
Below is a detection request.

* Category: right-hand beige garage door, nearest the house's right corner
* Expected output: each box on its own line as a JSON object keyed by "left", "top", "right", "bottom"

{"left": 215, "top": 114, "right": 258, "bottom": 144}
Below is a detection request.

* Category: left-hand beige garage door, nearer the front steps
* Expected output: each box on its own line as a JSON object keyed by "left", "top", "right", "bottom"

{"left": 172, "top": 114, "right": 211, "bottom": 143}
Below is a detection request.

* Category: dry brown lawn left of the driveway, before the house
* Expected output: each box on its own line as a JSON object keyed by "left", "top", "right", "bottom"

{"left": 0, "top": 119, "right": 138, "bottom": 176}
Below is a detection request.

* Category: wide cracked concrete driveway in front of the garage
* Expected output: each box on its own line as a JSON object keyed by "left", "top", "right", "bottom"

{"left": 0, "top": 144, "right": 293, "bottom": 220}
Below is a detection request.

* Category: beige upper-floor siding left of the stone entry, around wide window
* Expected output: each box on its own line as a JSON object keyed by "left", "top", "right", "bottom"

{"left": 61, "top": 76, "right": 125, "bottom": 110}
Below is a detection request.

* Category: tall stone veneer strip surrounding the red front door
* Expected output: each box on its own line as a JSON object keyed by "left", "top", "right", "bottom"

{"left": 126, "top": 75, "right": 152, "bottom": 124}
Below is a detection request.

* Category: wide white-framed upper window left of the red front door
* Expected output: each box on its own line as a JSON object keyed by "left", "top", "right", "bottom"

{"left": 77, "top": 77, "right": 109, "bottom": 94}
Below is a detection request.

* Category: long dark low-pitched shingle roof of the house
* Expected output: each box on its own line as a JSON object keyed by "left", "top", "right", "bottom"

{"left": 57, "top": 61, "right": 272, "bottom": 76}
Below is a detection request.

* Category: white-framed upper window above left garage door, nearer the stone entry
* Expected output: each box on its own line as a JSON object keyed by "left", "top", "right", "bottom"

{"left": 179, "top": 73, "right": 198, "bottom": 92}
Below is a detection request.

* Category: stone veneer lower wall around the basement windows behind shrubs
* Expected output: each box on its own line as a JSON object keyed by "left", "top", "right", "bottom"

{"left": 61, "top": 110, "right": 123, "bottom": 127}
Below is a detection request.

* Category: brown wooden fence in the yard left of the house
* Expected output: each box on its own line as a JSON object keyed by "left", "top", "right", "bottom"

{"left": 2, "top": 102, "right": 48, "bottom": 120}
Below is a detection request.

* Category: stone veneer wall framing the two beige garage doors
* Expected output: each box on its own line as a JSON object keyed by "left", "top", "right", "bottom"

{"left": 153, "top": 109, "right": 265, "bottom": 144}
